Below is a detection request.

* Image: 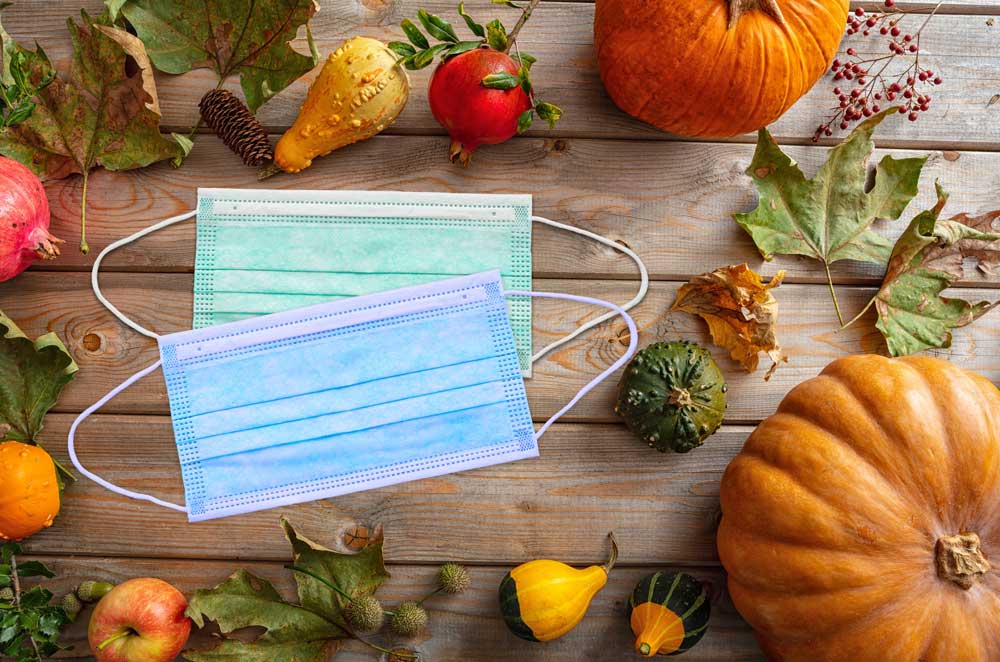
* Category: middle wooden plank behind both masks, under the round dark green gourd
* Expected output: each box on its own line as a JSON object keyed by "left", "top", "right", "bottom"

{"left": 0, "top": 272, "right": 1000, "bottom": 423}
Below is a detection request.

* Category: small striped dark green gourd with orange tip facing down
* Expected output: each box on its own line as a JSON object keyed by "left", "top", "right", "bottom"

{"left": 628, "top": 572, "right": 711, "bottom": 657}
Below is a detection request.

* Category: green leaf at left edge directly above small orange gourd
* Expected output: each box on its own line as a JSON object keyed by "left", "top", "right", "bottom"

{"left": 0, "top": 312, "right": 79, "bottom": 444}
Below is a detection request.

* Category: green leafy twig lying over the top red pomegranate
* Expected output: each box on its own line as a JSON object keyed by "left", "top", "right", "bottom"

{"left": 389, "top": 0, "right": 563, "bottom": 133}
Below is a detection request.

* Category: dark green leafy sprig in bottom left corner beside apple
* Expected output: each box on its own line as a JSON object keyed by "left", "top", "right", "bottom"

{"left": 0, "top": 542, "right": 70, "bottom": 662}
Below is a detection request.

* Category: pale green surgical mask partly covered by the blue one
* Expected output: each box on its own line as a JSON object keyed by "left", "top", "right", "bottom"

{"left": 135, "top": 189, "right": 648, "bottom": 377}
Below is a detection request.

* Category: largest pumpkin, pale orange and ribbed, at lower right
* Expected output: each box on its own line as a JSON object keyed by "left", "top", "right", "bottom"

{"left": 718, "top": 356, "right": 1000, "bottom": 662}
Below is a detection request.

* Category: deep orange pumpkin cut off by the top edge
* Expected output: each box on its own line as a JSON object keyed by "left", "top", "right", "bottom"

{"left": 594, "top": 0, "right": 848, "bottom": 138}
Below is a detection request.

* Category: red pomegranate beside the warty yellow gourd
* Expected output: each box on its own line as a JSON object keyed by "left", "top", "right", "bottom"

{"left": 428, "top": 46, "right": 531, "bottom": 166}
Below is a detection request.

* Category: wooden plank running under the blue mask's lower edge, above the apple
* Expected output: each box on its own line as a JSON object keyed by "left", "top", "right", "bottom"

{"left": 33, "top": 414, "right": 751, "bottom": 565}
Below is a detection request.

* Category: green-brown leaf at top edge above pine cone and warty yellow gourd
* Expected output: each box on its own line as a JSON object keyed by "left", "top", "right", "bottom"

{"left": 116, "top": 0, "right": 319, "bottom": 112}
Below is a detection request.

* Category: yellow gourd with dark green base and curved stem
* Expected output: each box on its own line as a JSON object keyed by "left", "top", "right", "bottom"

{"left": 500, "top": 534, "right": 618, "bottom": 641}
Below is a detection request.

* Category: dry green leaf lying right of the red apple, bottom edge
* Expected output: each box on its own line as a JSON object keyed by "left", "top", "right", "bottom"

{"left": 184, "top": 570, "right": 348, "bottom": 662}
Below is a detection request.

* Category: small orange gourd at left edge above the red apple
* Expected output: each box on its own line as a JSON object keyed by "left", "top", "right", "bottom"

{"left": 0, "top": 441, "right": 59, "bottom": 540}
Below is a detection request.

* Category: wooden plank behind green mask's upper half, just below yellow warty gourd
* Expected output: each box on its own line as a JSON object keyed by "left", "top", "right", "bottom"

{"left": 29, "top": 136, "right": 1000, "bottom": 286}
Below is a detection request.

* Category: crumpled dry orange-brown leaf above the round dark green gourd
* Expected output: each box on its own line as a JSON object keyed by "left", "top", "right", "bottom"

{"left": 670, "top": 264, "right": 788, "bottom": 380}
